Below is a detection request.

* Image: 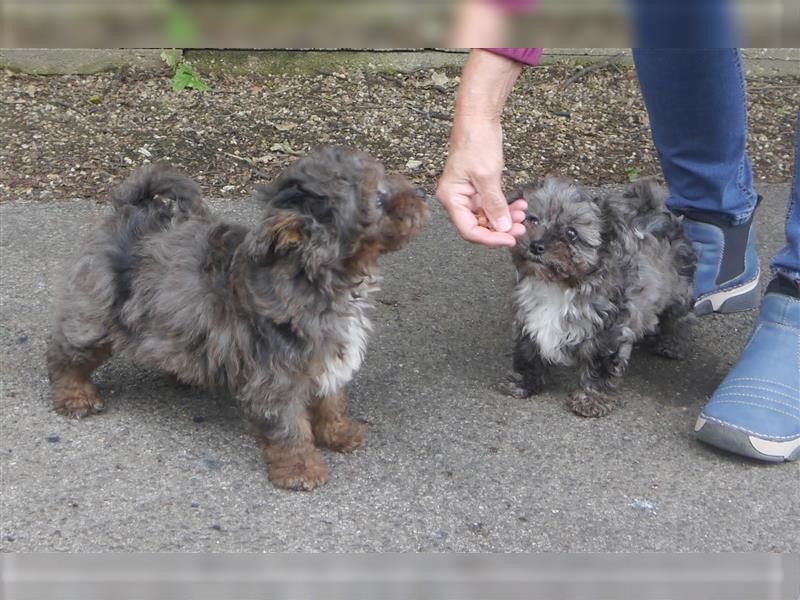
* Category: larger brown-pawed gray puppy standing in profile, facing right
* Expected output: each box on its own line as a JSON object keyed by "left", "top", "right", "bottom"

{"left": 47, "top": 148, "right": 428, "bottom": 490}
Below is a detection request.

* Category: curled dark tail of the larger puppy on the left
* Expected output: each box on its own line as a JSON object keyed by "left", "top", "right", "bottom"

{"left": 112, "top": 163, "right": 208, "bottom": 218}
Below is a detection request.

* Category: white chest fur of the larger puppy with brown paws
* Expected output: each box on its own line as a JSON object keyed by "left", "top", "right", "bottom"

{"left": 316, "top": 289, "right": 372, "bottom": 396}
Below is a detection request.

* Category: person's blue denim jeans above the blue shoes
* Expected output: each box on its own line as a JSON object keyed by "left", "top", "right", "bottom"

{"left": 633, "top": 45, "right": 800, "bottom": 279}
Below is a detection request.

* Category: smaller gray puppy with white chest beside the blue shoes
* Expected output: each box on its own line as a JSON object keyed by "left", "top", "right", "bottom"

{"left": 501, "top": 178, "right": 695, "bottom": 417}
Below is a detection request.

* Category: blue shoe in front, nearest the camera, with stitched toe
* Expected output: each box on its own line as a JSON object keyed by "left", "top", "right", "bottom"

{"left": 694, "top": 275, "right": 800, "bottom": 462}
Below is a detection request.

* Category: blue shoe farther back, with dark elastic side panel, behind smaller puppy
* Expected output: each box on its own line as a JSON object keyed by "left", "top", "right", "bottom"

{"left": 683, "top": 198, "right": 761, "bottom": 315}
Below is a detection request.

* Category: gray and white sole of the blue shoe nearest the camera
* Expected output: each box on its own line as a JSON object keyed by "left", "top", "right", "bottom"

{"left": 694, "top": 416, "right": 800, "bottom": 463}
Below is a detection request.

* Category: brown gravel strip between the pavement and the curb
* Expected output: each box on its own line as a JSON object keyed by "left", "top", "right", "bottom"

{"left": 0, "top": 65, "right": 800, "bottom": 201}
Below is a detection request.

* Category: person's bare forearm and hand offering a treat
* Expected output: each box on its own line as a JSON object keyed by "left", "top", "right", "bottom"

{"left": 436, "top": 50, "right": 526, "bottom": 247}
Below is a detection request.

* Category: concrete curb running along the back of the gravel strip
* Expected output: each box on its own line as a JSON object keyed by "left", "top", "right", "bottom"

{"left": 0, "top": 48, "right": 800, "bottom": 75}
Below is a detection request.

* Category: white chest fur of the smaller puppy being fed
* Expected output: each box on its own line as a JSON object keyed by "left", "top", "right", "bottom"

{"left": 514, "top": 278, "right": 587, "bottom": 365}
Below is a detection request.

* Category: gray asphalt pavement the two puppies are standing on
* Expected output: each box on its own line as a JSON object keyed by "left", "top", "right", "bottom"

{"left": 0, "top": 185, "right": 800, "bottom": 552}
